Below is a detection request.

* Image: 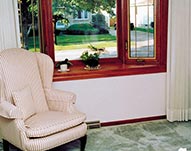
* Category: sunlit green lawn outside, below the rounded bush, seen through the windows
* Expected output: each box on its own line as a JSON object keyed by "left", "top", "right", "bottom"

{"left": 29, "top": 34, "right": 117, "bottom": 51}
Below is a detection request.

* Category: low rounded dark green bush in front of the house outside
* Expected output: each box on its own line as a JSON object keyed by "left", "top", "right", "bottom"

{"left": 66, "top": 23, "right": 99, "bottom": 35}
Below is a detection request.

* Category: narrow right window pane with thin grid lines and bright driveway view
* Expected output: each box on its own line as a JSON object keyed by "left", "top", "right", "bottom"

{"left": 129, "top": 0, "right": 155, "bottom": 58}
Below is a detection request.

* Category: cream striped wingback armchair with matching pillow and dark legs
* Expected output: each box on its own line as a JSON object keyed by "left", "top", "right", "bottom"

{"left": 0, "top": 49, "right": 87, "bottom": 151}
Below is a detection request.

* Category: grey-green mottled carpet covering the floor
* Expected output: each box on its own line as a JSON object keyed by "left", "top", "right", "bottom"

{"left": 0, "top": 120, "right": 191, "bottom": 151}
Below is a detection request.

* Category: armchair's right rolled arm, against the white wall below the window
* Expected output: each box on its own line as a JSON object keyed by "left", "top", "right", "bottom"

{"left": 45, "top": 89, "right": 76, "bottom": 112}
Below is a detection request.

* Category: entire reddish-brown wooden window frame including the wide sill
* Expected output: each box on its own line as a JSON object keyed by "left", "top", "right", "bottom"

{"left": 39, "top": 0, "right": 168, "bottom": 81}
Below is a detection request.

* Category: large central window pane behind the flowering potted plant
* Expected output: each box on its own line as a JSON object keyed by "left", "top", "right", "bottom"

{"left": 52, "top": 0, "right": 117, "bottom": 61}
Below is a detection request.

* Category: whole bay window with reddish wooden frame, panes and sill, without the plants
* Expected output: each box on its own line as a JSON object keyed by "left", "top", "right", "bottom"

{"left": 17, "top": 0, "right": 168, "bottom": 79}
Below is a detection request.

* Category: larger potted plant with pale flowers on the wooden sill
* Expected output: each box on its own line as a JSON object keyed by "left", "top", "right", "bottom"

{"left": 80, "top": 44, "right": 105, "bottom": 70}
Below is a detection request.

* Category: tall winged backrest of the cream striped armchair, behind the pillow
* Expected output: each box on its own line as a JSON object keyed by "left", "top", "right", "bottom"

{"left": 0, "top": 48, "right": 50, "bottom": 113}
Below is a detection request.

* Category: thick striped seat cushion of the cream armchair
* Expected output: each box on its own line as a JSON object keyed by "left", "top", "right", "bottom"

{"left": 25, "top": 111, "right": 86, "bottom": 138}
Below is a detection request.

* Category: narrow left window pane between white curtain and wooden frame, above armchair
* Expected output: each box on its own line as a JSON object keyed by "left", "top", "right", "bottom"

{"left": 18, "top": 0, "right": 40, "bottom": 51}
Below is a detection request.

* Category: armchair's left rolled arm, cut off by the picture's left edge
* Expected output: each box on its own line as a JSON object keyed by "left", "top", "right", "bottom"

{"left": 0, "top": 101, "right": 23, "bottom": 119}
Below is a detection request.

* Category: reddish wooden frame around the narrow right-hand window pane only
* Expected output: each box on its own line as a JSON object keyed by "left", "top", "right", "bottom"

{"left": 121, "top": 0, "right": 168, "bottom": 65}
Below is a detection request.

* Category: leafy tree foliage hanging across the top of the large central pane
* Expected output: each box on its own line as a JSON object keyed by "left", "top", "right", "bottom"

{"left": 52, "top": 0, "right": 116, "bottom": 44}
